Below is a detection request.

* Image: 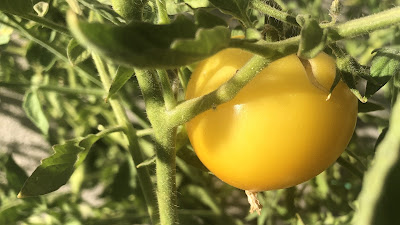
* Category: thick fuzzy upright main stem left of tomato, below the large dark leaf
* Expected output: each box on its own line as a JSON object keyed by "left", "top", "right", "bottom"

{"left": 135, "top": 69, "right": 178, "bottom": 225}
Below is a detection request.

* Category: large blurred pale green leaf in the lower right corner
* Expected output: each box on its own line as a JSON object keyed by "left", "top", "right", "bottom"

{"left": 354, "top": 93, "right": 400, "bottom": 225}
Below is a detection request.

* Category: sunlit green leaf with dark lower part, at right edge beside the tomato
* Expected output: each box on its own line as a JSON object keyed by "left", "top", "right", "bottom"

{"left": 365, "top": 46, "right": 400, "bottom": 97}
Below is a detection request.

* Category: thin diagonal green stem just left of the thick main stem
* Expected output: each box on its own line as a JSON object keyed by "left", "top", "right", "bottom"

{"left": 93, "top": 54, "right": 159, "bottom": 224}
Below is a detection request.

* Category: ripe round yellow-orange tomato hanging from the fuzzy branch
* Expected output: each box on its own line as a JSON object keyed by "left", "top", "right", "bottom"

{"left": 186, "top": 49, "right": 358, "bottom": 191}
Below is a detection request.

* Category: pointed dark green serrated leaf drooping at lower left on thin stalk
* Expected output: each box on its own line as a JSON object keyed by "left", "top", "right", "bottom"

{"left": 18, "top": 134, "right": 101, "bottom": 198}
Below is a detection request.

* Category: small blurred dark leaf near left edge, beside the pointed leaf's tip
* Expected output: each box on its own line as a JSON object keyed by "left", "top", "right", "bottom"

{"left": 5, "top": 155, "right": 28, "bottom": 190}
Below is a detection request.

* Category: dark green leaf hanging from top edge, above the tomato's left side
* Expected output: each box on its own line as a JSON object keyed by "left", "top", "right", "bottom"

{"left": 209, "top": 0, "right": 251, "bottom": 27}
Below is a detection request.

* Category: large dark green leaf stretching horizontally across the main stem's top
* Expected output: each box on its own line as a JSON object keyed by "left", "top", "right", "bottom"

{"left": 67, "top": 13, "right": 230, "bottom": 69}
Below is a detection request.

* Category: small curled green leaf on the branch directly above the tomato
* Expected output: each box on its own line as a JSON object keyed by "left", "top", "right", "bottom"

{"left": 297, "top": 18, "right": 327, "bottom": 59}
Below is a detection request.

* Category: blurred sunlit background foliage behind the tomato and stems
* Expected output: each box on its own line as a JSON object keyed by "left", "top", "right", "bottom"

{"left": 0, "top": 0, "right": 400, "bottom": 225}
